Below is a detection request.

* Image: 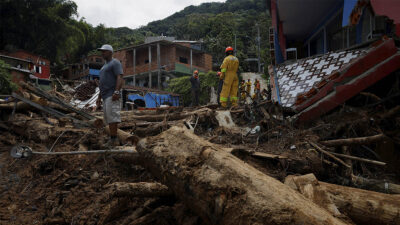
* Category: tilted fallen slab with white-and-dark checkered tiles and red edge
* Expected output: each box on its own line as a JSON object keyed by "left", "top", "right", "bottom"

{"left": 276, "top": 38, "right": 400, "bottom": 121}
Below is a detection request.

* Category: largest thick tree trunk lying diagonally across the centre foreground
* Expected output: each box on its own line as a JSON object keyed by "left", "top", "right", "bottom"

{"left": 137, "top": 127, "right": 348, "bottom": 225}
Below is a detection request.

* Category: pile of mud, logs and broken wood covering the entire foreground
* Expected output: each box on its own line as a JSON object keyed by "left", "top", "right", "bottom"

{"left": 0, "top": 77, "right": 400, "bottom": 225}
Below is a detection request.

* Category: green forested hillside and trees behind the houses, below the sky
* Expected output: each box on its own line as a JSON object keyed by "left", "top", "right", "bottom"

{"left": 0, "top": 0, "right": 269, "bottom": 70}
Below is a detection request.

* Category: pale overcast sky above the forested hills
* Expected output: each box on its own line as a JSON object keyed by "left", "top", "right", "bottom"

{"left": 74, "top": 0, "right": 225, "bottom": 28}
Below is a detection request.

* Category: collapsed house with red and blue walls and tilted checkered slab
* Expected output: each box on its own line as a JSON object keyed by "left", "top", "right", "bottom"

{"left": 268, "top": 0, "right": 400, "bottom": 122}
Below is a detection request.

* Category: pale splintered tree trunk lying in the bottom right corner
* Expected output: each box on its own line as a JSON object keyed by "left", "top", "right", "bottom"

{"left": 285, "top": 174, "right": 400, "bottom": 225}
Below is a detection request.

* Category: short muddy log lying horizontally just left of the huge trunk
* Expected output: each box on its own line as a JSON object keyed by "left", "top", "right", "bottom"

{"left": 108, "top": 182, "right": 172, "bottom": 197}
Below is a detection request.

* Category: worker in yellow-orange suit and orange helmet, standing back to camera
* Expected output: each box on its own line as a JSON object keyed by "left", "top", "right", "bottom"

{"left": 219, "top": 46, "right": 239, "bottom": 108}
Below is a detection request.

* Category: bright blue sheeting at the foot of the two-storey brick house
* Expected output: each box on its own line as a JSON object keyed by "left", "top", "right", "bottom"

{"left": 128, "top": 93, "right": 179, "bottom": 108}
